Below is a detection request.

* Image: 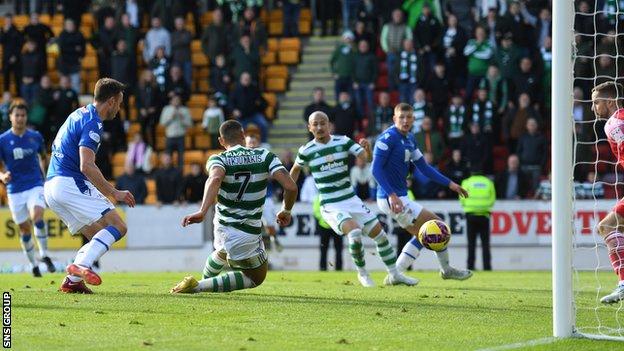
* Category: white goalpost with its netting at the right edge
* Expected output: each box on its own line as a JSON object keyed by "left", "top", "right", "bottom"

{"left": 551, "top": 0, "right": 624, "bottom": 341}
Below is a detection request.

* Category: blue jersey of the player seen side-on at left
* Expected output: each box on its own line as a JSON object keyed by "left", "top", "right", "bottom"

{"left": 47, "top": 104, "right": 103, "bottom": 190}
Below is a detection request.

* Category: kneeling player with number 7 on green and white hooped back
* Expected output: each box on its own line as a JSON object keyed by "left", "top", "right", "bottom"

{"left": 171, "top": 120, "right": 297, "bottom": 293}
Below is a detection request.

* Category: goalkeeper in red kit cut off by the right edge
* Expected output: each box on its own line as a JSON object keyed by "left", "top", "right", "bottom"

{"left": 592, "top": 82, "right": 624, "bottom": 303}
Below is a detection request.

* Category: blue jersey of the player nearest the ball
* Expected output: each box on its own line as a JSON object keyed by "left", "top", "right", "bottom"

{"left": 372, "top": 126, "right": 423, "bottom": 198}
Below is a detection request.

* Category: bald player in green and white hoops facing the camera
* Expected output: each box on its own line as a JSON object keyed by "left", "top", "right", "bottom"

{"left": 290, "top": 111, "right": 418, "bottom": 287}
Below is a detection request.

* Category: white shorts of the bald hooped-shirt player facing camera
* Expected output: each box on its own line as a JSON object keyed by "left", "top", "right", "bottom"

{"left": 321, "top": 196, "right": 377, "bottom": 235}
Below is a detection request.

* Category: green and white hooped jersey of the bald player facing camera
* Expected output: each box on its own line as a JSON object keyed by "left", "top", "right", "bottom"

{"left": 295, "top": 135, "right": 364, "bottom": 205}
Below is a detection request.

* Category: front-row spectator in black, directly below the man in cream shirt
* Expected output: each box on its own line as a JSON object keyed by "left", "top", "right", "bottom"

{"left": 154, "top": 152, "right": 182, "bottom": 206}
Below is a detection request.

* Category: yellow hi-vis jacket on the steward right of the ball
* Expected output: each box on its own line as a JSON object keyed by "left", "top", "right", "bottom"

{"left": 459, "top": 175, "right": 496, "bottom": 216}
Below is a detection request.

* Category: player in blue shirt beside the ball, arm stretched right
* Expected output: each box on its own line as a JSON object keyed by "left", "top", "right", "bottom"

{"left": 372, "top": 103, "right": 472, "bottom": 280}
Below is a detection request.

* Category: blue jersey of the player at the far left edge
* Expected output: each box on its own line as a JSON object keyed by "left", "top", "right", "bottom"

{"left": 0, "top": 129, "right": 45, "bottom": 194}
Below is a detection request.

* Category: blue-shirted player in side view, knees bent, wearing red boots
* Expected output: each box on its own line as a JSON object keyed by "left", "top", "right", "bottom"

{"left": 44, "top": 78, "right": 135, "bottom": 294}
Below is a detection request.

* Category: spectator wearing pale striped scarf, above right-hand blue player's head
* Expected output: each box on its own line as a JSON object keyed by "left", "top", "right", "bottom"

{"left": 393, "top": 39, "right": 424, "bottom": 105}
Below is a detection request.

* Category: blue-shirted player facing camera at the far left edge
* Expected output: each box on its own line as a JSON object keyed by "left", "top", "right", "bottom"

{"left": 0, "top": 101, "right": 55, "bottom": 277}
